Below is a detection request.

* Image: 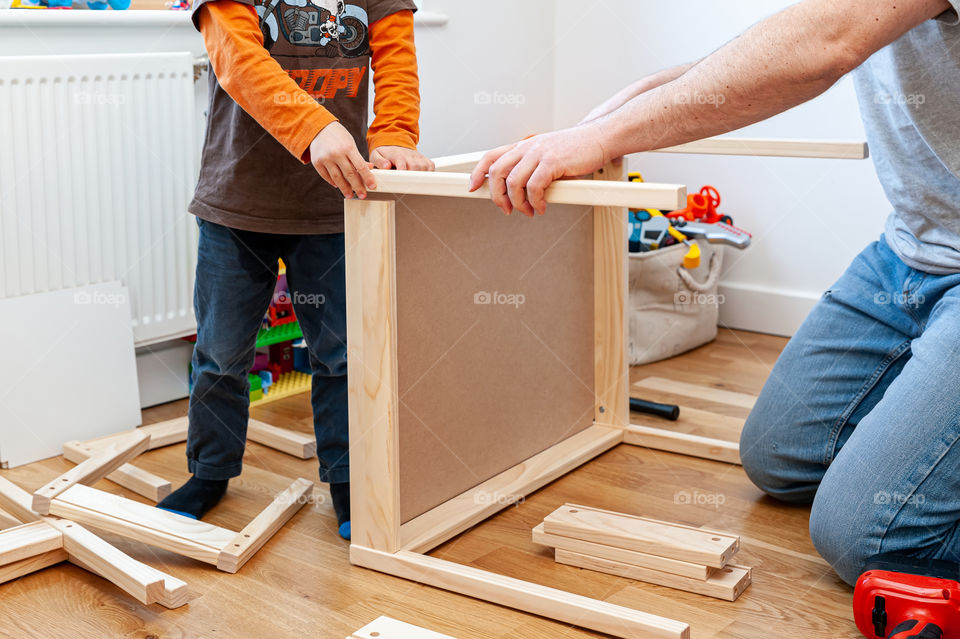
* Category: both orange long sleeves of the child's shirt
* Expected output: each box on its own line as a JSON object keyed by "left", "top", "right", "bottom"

{"left": 197, "top": 0, "right": 420, "bottom": 162}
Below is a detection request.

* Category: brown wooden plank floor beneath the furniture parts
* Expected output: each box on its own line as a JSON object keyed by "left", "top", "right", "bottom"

{"left": 0, "top": 330, "right": 858, "bottom": 639}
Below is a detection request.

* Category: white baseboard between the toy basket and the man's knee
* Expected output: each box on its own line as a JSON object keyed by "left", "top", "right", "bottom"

{"left": 718, "top": 282, "right": 820, "bottom": 337}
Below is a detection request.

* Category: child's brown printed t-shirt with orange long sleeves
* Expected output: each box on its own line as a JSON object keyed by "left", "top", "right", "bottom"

{"left": 189, "top": 0, "right": 419, "bottom": 234}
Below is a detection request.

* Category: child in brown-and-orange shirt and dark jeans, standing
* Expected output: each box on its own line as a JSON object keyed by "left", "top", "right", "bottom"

{"left": 158, "top": 0, "right": 433, "bottom": 539}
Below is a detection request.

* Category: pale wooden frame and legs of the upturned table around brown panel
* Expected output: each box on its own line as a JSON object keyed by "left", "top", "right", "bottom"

{"left": 345, "top": 138, "right": 867, "bottom": 639}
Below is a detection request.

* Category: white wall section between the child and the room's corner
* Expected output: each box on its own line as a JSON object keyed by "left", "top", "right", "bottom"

{"left": 416, "top": 0, "right": 555, "bottom": 157}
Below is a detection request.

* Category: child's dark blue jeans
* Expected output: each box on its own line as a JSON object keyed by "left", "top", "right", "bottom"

{"left": 187, "top": 220, "right": 350, "bottom": 483}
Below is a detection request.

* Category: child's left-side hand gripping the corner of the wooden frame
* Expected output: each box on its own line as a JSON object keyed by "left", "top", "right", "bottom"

{"left": 310, "top": 122, "right": 377, "bottom": 200}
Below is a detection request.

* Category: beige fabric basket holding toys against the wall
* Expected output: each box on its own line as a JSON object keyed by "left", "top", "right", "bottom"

{"left": 627, "top": 242, "right": 723, "bottom": 365}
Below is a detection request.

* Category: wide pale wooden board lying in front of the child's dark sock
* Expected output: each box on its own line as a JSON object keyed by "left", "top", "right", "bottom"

{"left": 50, "top": 484, "right": 237, "bottom": 565}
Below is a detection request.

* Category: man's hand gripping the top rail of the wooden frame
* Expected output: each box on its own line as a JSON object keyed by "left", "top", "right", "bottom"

{"left": 470, "top": 123, "right": 609, "bottom": 217}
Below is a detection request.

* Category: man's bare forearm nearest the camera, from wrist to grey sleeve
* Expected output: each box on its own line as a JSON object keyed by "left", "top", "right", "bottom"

{"left": 591, "top": 0, "right": 946, "bottom": 157}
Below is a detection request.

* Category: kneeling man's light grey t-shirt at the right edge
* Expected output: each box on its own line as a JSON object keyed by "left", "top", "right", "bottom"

{"left": 853, "top": 0, "right": 960, "bottom": 275}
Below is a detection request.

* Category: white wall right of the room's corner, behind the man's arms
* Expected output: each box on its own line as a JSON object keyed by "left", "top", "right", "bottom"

{"left": 554, "top": 0, "right": 890, "bottom": 334}
